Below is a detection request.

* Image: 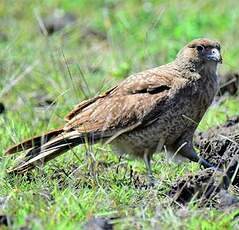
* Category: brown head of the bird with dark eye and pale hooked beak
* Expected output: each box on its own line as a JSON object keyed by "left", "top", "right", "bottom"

{"left": 176, "top": 38, "right": 222, "bottom": 73}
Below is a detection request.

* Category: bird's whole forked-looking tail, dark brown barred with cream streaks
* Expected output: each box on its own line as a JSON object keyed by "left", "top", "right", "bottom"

{"left": 7, "top": 130, "right": 101, "bottom": 174}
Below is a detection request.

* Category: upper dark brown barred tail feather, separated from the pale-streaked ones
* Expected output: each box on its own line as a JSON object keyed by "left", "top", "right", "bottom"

{"left": 5, "top": 128, "right": 63, "bottom": 154}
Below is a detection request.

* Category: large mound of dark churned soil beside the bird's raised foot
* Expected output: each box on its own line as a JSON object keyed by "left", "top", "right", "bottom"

{"left": 168, "top": 116, "right": 239, "bottom": 209}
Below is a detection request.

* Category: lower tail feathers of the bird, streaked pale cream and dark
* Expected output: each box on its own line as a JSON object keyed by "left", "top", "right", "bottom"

{"left": 8, "top": 131, "right": 106, "bottom": 174}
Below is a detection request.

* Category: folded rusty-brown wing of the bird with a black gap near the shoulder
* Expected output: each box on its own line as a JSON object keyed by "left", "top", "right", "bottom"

{"left": 64, "top": 70, "right": 183, "bottom": 135}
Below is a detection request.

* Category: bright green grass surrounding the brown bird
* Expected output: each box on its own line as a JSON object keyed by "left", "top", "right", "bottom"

{"left": 0, "top": 0, "right": 239, "bottom": 229}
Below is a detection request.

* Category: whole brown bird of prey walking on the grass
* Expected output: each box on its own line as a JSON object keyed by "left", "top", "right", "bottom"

{"left": 6, "top": 38, "right": 222, "bottom": 180}
